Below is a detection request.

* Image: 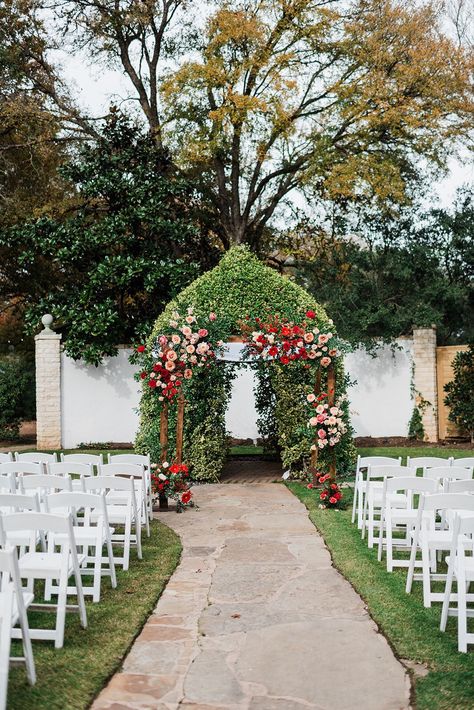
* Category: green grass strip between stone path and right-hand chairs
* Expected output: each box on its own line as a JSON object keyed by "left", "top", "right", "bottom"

{"left": 286, "top": 482, "right": 474, "bottom": 710}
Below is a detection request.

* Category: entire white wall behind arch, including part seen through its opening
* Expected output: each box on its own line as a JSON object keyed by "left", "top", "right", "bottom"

{"left": 61, "top": 338, "right": 413, "bottom": 448}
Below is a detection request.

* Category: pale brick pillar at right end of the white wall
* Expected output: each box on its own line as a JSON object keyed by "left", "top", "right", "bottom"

{"left": 413, "top": 326, "right": 438, "bottom": 441}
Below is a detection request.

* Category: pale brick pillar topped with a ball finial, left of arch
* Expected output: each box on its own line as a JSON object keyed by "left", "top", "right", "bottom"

{"left": 35, "top": 314, "right": 61, "bottom": 450}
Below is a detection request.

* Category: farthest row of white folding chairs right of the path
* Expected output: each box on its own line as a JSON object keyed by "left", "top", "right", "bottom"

{"left": 352, "top": 456, "right": 474, "bottom": 530}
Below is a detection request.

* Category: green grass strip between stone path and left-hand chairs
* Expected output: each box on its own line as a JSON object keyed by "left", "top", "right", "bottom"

{"left": 8, "top": 520, "right": 181, "bottom": 710}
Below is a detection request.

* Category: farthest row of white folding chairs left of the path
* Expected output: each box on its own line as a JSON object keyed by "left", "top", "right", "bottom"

{"left": 0, "top": 461, "right": 150, "bottom": 536}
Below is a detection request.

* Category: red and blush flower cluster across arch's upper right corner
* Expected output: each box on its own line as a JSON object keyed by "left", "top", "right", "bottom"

{"left": 242, "top": 310, "right": 339, "bottom": 367}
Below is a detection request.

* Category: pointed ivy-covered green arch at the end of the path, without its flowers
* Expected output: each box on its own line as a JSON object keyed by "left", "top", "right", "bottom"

{"left": 136, "top": 246, "right": 353, "bottom": 481}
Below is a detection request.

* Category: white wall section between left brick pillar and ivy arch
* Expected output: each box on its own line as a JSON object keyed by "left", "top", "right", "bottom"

{"left": 61, "top": 348, "right": 140, "bottom": 449}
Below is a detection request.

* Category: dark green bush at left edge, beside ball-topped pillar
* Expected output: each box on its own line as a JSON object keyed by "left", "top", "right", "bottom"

{"left": 0, "top": 356, "right": 35, "bottom": 440}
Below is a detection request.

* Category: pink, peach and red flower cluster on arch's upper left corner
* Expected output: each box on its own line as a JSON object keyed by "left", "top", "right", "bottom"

{"left": 136, "top": 306, "right": 222, "bottom": 402}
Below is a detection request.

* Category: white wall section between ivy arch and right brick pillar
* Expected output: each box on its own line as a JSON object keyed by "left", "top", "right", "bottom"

{"left": 344, "top": 338, "right": 413, "bottom": 437}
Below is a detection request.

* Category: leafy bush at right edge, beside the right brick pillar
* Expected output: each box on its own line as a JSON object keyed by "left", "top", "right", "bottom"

{"left": 444, "top": 345, "right": 474, "bottom": 442}
